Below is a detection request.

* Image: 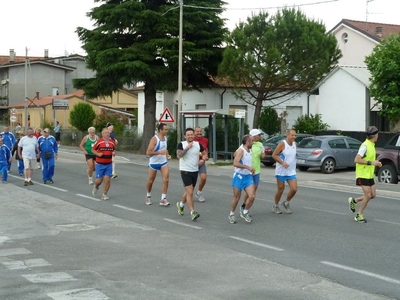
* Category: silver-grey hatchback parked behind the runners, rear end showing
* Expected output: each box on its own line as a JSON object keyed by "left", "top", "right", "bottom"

{"left": 296, "top": 135, "right": 361, "bottom": 174}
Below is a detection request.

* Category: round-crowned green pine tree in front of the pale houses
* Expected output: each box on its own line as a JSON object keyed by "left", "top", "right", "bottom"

{"left": 219, "top": 8, "right": 341, "bottom": 128}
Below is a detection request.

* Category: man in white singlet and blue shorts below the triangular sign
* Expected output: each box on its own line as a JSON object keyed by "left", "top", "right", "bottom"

{"left": 145, "top": 123, "right": 171, "bottom": 206}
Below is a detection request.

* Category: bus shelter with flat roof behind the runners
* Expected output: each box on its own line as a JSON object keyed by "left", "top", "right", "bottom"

{"left": 178, "top": 109, "right": 244, "bottom": 163}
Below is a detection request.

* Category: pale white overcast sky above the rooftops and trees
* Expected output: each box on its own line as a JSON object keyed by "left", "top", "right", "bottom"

{"left": 0, "top": 0, "right": 400, "bottom": 57}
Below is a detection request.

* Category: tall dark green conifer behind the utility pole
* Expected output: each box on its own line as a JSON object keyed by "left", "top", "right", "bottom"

{"left": 74, "top": 0, "right": 226, "bottom": 152}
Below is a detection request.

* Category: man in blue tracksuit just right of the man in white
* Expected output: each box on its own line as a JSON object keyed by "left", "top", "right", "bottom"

{"left": 38, "top": 128, "right": 58, "bottom": 184}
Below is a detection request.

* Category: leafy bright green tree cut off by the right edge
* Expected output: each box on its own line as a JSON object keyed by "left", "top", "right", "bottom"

{"left": 365, "top": 33, "right": 400, "bottom": 122}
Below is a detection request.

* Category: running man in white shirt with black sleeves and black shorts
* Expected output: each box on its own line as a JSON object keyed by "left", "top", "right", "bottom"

{"left": 176, "top": 128, "right": 207, "bottom": 221}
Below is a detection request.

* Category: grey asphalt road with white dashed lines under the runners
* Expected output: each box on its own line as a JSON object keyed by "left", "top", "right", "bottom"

{"left": 0, "top": 147, "right": 400, "bottom": 299}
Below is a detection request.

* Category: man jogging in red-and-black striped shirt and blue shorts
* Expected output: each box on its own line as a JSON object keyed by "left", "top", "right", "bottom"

{"left": 92, "top": 128, "right": 115, "bottom": 200}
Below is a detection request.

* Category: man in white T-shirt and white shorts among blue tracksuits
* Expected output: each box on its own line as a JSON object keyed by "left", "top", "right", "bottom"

{"left": 18, "top": 127, "right": 40, "bottom": 186}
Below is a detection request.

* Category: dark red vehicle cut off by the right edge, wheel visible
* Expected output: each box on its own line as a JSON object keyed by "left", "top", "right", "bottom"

{"left": 375, "top": 133, "right": 400, "bottom": 184}
